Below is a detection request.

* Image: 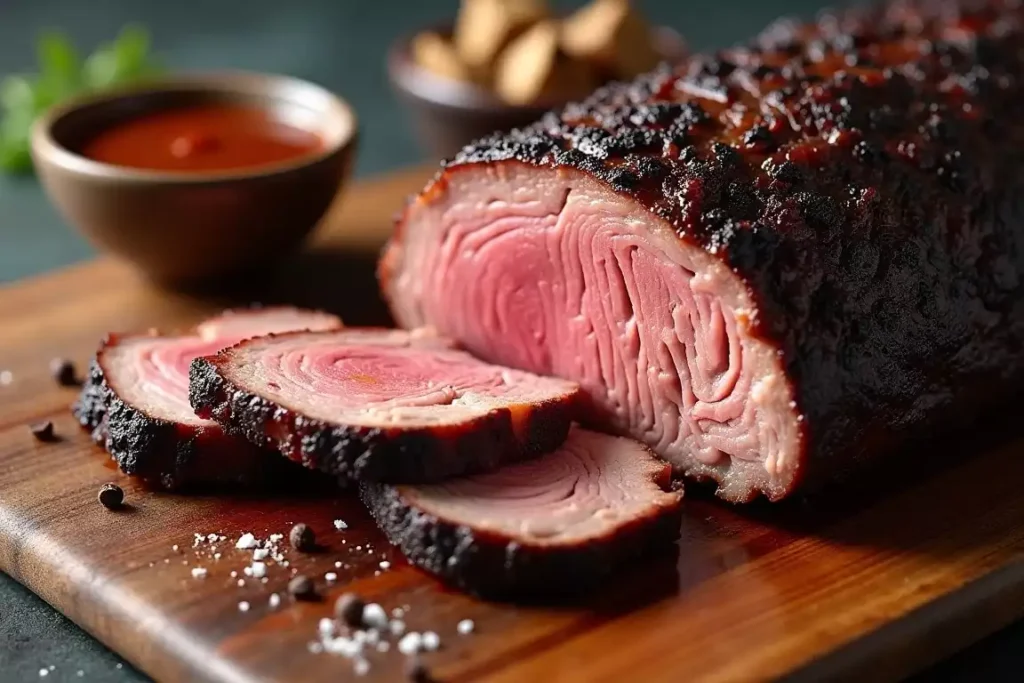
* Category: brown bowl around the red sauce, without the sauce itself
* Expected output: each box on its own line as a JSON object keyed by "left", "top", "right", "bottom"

{"left": 32, "top": 73, "right": 357, "bottom": 287}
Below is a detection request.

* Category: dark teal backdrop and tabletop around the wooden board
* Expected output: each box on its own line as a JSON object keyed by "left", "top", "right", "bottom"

{"left": 0, "top": 0, "right": 1024, "bottom": 683}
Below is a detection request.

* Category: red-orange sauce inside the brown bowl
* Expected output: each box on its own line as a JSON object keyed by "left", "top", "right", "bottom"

{"left": 81, "top": 104, "right": 324, "bottom": 173}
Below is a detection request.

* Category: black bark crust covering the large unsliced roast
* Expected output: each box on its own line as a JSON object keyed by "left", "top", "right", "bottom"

{"left": 380, "top": 0, "right": 1024, "bottom": 501}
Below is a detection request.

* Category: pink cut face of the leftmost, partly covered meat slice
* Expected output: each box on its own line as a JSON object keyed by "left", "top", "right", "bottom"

{"left": 100, "top": 308, "right": 340, "bottom": 427}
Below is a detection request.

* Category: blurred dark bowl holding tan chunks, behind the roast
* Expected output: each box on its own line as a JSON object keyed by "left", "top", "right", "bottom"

{"left": 387, "top": 26, "right": 687, "bottom": 159}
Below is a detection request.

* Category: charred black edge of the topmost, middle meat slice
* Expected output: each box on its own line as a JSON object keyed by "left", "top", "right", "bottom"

{"left": 188, "top": 356, "right": 580, "bottom": 483}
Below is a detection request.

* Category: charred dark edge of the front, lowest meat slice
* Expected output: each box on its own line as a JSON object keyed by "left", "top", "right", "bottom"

{"left": 359, "top": 475, "right": 683, "bottom": 600}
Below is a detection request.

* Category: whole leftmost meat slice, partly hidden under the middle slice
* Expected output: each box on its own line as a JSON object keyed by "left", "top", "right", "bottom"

{"left": 73, "top": 307, "right": 341, "bottom": 489}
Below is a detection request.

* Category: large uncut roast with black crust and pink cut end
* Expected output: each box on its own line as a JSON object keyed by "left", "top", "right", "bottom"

{"left": 379, "top": 0, "right": 1024, "bottom": 502}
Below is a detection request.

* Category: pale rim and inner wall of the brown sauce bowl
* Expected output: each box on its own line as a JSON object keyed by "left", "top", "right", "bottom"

{"left": 31, "top": 71, "right": 358, "bottom": 185}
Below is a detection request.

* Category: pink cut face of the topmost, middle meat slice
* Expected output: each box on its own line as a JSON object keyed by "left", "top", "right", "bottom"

{"left": 211, "top": 329, "right": 579, "bottom": 427}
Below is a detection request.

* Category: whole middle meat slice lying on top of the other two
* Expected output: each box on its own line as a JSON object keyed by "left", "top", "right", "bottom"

{"left": 189, "top": 329, "right": 580, "bottom": 482}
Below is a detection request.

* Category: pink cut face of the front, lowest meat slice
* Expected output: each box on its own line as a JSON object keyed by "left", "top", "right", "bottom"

{"left": 398, "top": 427, "right": 679, "bottom": 545}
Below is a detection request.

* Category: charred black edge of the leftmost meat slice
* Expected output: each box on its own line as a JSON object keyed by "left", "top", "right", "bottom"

{"left": 72, "top": 336, "right": 282, "bottom": 490}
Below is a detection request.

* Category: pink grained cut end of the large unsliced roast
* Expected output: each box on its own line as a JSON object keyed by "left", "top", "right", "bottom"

{"left": 384, "top": 164, "right": 800, "bottom": 497}
